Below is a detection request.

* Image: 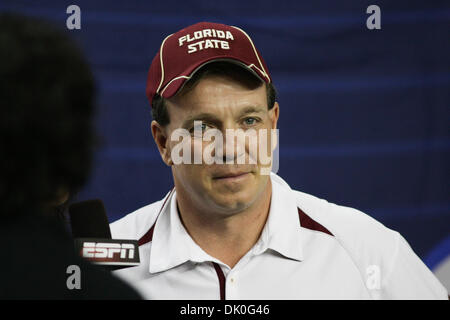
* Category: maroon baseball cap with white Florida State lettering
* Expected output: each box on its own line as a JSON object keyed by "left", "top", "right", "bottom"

{"left": 146, "top": 22, "right": 271, "bottom": 105}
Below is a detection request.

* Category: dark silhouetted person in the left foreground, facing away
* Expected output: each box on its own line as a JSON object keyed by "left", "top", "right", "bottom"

{"left": 0, "top": 14, "right": 140, "bottom": 300}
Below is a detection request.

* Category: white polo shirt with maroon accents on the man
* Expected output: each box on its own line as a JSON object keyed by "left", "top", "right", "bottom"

{"left": 111, "top": 174, "right": 448, "bottom": 300}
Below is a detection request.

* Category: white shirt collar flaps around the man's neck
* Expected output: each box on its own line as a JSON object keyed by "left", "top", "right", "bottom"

{"left": 149, "top": 174, "right": 303, "bottom": 273}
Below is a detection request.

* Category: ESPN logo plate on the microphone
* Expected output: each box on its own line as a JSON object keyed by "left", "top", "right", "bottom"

{"left": 75, "top": 238, "right": 139, "bottom": 268}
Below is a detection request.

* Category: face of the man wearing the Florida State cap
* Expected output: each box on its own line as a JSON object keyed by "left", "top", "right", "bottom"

{"left": 156, "top": 75, "right": 279, "bottom": 215}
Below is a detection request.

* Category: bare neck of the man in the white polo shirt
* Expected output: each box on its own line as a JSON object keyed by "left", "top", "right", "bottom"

{"left": 177, "top": 179, "right": 272, "bottom": 268}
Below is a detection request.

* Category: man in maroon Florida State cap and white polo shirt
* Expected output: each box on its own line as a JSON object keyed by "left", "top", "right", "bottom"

{"left": 111, "top": 22, "right": 447, "bottom": 299}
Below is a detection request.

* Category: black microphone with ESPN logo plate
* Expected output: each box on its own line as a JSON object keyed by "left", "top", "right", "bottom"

{"left": 69, "top": 199, "right": 140, "bottom": 270}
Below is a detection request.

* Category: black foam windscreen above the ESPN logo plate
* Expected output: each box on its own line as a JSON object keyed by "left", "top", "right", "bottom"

{"left": 69, "top": 199, "right": 111, "bottom": 239}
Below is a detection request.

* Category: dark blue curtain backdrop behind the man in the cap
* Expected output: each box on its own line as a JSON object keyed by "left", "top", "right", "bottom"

{"left": 0, "top": 0, "right": 450, "bottom": 274}
